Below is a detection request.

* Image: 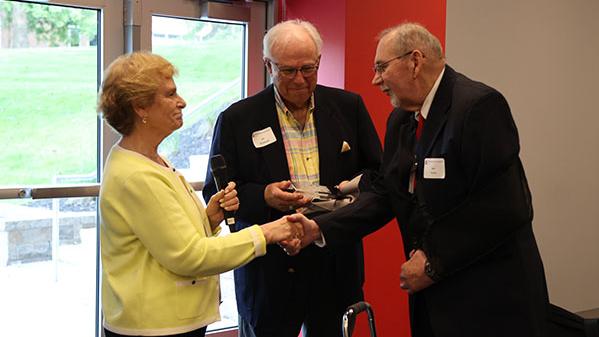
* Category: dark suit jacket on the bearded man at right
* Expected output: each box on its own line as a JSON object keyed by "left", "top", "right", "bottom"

{"left": 316, "top": 66, "right": 547, "bottom": 337}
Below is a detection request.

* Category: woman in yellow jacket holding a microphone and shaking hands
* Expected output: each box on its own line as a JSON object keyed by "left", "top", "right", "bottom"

{"left": 98, "top": 52, "right": 301, "bottom": 336}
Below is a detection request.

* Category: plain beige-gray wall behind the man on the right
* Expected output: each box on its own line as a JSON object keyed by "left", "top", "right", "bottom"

{"left": 446, "top": 0, "right": 599, "bottom": 311}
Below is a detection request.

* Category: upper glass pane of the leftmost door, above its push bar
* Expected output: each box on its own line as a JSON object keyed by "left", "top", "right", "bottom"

{"left": 0, "top": 1, "right": 99, "bottom": 186}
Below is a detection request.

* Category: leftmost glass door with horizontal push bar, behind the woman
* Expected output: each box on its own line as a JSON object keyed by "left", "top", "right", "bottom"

{"left": 0, "top": 0, "right": 123, "bottom": 337}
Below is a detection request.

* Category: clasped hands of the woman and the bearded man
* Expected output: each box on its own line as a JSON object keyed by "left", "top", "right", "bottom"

{"left": 260, "top": 213, "right": 321, "bottom": 255}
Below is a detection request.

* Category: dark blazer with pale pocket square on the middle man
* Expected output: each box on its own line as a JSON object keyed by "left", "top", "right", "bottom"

{"left": 203, "top": 85, "right": 382, "bottom": 326}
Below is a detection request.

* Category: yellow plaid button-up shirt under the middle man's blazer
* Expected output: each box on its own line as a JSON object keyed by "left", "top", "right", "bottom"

{"left": 275, "top": 86, "right": 320, "bottom": 188}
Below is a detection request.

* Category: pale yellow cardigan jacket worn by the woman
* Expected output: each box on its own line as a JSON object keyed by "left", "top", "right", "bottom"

{"left": 100, "top": 145, "right": 266, "bottom": 336}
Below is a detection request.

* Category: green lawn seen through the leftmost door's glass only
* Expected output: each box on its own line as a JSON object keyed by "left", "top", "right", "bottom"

{"left": 0, "top": 48, "right": 97, "bottom": 185}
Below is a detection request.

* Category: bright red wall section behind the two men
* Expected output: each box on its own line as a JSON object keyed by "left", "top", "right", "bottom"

{"left": 279, "top": 0, "right": 446, "bottom": 337}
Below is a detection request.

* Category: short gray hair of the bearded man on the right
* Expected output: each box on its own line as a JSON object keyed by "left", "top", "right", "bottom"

{"left": 379, "top": 22, "right": 443, "bottom": 59}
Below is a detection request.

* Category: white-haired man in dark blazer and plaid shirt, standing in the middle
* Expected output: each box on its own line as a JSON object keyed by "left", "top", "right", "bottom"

{"left": 203, "top": 20, "right": 382, "bottom": 337}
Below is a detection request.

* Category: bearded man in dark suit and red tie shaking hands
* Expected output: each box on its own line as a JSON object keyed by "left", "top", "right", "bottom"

{"left": 288, "top": 23, "right": 548, "bottom": 337}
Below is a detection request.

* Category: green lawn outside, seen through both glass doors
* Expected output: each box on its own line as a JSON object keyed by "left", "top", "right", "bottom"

{"left": 0, "top": 41, "right": 241, "bottom": 186}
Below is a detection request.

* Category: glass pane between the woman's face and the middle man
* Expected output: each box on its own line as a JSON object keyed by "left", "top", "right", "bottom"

{"left": 152, "top": 16, "right": 245, "bottom": 181}
